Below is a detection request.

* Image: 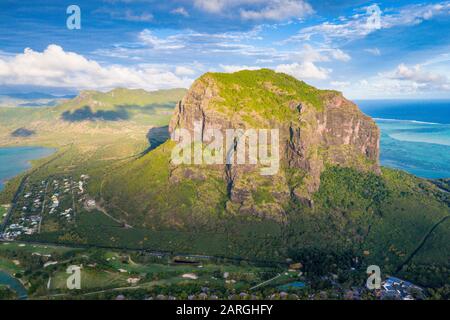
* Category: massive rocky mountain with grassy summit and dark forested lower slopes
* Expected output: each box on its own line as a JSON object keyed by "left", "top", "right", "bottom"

{"left": 97, "top": 70, "right": 450, "bottom": 281}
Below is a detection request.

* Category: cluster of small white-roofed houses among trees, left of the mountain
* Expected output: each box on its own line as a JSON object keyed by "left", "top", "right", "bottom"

{"left": 0, "top": 174, "right": 91, "bottom": 240}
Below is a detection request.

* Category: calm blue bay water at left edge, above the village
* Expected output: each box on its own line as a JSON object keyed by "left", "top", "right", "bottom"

{"left": 0, "top": 147, "right": 55, "bottom": 191}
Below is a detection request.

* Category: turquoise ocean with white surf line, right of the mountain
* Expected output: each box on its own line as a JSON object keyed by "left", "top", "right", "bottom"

{"left": 355, "top": 100, "right": 450, "bottom": 179}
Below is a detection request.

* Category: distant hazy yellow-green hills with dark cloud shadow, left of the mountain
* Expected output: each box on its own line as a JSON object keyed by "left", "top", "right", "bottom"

{"left": 0, "top": 88, "right": 187, "bottom": 132}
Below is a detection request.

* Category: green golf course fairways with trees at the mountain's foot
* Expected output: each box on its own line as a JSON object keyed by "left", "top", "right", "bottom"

{"left": 0, "top": 243, "right": 306, "bottom": 299}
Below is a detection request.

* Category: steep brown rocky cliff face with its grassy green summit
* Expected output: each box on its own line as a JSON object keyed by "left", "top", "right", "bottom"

{"left": 169, "top": 70, "right": 380, "bottom": 220}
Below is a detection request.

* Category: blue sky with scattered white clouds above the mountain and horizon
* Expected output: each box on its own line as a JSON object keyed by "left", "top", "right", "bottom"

{"left": 0, "top": 0, "right": 450, "bottom": 99}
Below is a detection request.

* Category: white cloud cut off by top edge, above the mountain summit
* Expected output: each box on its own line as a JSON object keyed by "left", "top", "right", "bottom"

{"left": 194, "top": 0, "right": 314, "bottom": 21}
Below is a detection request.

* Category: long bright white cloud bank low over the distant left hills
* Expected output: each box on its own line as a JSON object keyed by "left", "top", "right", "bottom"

{"left": 0, "top": 44, "right": 193, "bottom": 90}
